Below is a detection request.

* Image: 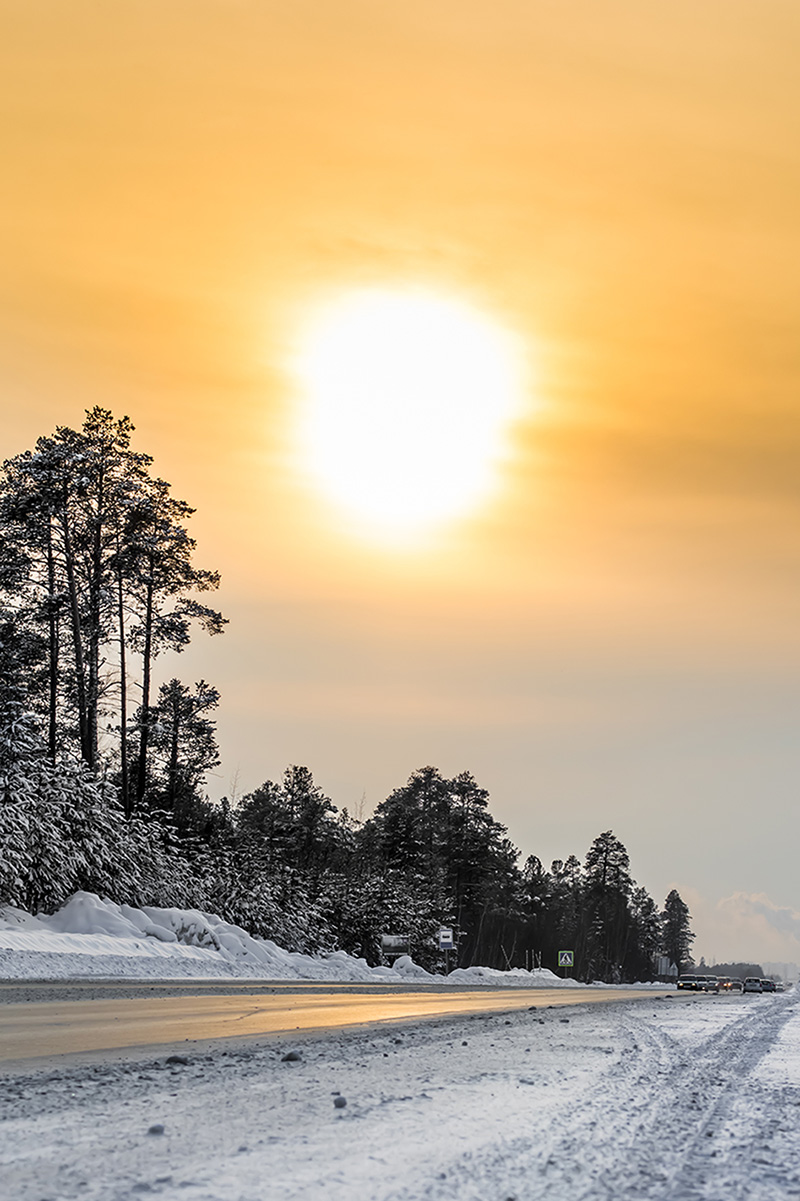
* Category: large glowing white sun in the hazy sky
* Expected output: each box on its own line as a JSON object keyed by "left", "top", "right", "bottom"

{"left": 292, "top": 288, "right": 524, "bottom": 539}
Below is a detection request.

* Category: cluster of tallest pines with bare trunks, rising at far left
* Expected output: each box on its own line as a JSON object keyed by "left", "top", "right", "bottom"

{"left": 0, "top": 406, "right": 225, "bottom": 815}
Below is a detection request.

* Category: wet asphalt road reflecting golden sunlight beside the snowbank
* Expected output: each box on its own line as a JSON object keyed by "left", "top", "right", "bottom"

{"left": 0, "top": 984, "right": 667, "bottom": 1063}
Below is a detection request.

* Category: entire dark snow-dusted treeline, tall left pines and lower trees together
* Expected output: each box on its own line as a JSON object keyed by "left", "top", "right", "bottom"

{"left": 0, "top": 408, "right": 693, "bottom": 980}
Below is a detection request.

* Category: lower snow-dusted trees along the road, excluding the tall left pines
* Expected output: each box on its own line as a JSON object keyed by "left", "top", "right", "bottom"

{"left": 0, "top": 691, "right": 692, "bottom": 981}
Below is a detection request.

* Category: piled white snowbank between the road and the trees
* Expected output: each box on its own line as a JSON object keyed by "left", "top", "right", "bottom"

{"left": 0, "top": 892, "right": 663, "bottom": 988}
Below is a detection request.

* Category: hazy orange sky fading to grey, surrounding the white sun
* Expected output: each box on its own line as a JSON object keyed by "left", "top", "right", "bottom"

{"left": 0, "top": 0, "right": 800, "bottom": 960}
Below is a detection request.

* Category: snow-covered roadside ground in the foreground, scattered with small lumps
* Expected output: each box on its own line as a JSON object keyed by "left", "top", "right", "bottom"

{"left": 0, "top": 992, "right": 800, "bottom": 1201}
